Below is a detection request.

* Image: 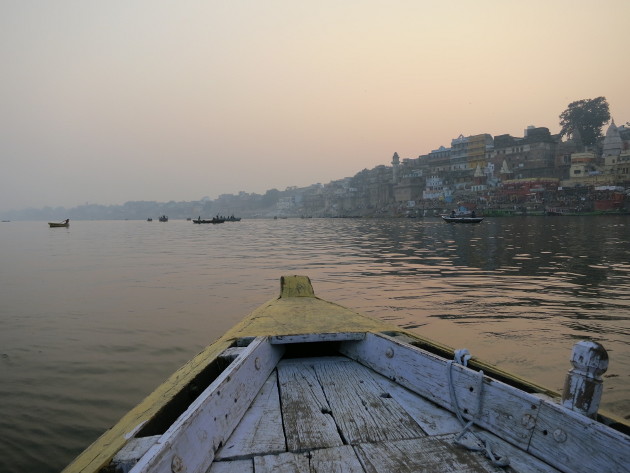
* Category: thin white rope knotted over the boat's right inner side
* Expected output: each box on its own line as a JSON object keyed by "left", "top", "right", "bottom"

{"left": 446, "top": 348, "right": 510, "bottom": 467}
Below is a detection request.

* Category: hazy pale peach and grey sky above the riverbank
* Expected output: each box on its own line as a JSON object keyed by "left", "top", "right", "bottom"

{"left": 0, "top": 0, "right": 630, "bottom": 210}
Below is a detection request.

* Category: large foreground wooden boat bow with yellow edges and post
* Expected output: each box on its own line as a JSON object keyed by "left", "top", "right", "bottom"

{"left": 62, "top": 276, "right": 630, "bottom": 473}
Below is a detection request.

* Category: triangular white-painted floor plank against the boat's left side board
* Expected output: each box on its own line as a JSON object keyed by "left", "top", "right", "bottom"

{"left": 215, "top": 371, "right": 286, "bottom": 460}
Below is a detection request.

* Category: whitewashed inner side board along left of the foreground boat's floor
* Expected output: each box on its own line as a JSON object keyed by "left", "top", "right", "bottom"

{"left": 132, "top": 338, "right": 283, "bottom": 473}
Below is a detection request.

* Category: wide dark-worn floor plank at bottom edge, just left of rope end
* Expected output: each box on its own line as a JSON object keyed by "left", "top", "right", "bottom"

{"left": 354, "top": 436, "right": 505, "bottom": 473}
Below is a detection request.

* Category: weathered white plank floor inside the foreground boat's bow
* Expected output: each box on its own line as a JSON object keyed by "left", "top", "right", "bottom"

{"left": 208, "top": 356, "right": 557, "bottom": 473}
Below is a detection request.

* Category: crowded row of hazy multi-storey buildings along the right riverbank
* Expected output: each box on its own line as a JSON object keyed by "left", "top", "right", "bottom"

{"left": 268, "top": 120, "right": 630, "bottom": 216}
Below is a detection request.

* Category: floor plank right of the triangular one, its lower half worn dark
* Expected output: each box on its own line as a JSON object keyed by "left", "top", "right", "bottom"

{"left": 278, "top": 360, "right": 343, "bottom": 452}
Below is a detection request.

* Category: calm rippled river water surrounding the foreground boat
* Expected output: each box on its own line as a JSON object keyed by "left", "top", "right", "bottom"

{"left": 0, "top": 216, "right": 630, "bottom": 473}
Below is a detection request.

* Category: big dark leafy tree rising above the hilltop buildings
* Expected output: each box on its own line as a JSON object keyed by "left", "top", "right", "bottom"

{"left": 560, "top": 97, "right": 610, "bottom": 146}
